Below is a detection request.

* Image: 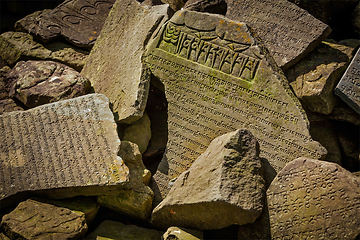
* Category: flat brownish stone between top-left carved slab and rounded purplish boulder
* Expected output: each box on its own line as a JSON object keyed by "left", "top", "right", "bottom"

{"left": 0, "top": 32, "right": 88, "bottom": 71}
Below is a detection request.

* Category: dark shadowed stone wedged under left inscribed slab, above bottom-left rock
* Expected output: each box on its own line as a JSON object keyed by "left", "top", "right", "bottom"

{"left": 35, "top": 196, "right": 100, "bottom": 226}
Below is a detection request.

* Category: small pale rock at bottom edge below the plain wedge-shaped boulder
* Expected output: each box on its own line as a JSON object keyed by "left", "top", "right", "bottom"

{"left": 162, "top": 227, "right": 204, "bottom": 240}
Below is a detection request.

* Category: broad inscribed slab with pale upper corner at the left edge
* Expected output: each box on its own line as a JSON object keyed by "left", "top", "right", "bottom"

{"left": 0, "top": 94, "right": 129, "bottom": 207}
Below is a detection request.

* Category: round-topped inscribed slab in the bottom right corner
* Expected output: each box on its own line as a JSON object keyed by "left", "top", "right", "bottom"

{"left": 267, "top": 158, "right": 360, "bottom": 239}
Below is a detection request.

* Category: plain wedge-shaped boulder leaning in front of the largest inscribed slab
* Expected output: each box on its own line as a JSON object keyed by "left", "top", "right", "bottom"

{"left": 151, "top": 129, "right": 265, "bottom": 230}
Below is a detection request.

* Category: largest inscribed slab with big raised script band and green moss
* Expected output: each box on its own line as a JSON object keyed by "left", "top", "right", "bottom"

{"left": 144, "top": 10, "right": 326, "bottom": 200}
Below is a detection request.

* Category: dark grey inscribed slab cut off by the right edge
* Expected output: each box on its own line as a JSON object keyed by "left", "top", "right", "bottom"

{"left": 335, "top": 49, "right": 360, "bottom": 115}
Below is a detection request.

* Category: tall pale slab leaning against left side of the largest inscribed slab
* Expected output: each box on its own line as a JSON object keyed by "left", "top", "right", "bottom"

{"left": 81, "top": 0, "right": 169, "bottom": 124}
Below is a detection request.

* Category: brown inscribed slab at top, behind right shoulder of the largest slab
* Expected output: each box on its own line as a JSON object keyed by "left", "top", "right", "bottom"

{"left": 225, "top": 0, "right": 331, "bottom": 70}
